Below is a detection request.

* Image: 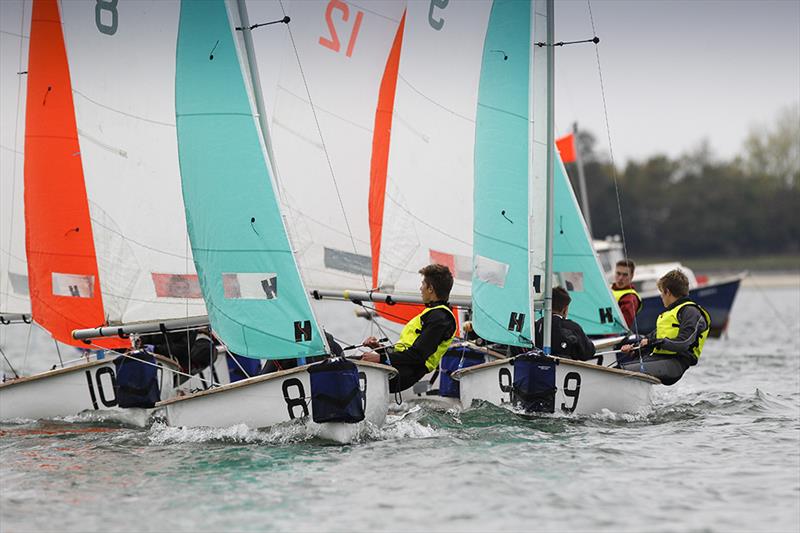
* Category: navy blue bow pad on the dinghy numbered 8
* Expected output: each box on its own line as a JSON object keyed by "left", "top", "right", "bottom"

{"left": 308, "top": 357, "right": 364, "bottom": 424}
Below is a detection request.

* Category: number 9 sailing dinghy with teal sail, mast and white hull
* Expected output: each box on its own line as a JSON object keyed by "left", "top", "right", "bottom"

{"left": 452, "top": 0, "right": 660, "bottom": 414}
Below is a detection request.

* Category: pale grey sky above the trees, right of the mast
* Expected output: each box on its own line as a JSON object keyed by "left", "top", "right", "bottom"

{"left": 556, "top": 0, "right": 800, "bottom": 164}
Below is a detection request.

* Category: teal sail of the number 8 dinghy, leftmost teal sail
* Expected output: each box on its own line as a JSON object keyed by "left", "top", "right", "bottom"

{"left": 175, "top": 0, "right": 326, "bottom": 359}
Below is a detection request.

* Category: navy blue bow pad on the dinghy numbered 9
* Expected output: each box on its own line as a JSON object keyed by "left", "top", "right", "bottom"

{"left": 512, "top": 349, "right": 558, "bottom": 413}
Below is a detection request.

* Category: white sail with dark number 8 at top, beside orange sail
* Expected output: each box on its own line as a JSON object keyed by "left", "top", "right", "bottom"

{"left": 61, "top": 0, "right": 206, "bottom": 323}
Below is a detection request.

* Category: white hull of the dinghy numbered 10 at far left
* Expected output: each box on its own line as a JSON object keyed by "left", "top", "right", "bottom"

{"left": 0, "top": 357, "right": 177, "bottom": 420}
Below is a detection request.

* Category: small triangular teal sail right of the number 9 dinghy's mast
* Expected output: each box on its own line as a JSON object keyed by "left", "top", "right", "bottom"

{"left": 548, "top": 156, "right": 627, "bottom": 335}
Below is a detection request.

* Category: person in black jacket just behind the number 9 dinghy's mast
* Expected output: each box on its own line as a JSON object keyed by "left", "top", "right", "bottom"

{"left": 534, "top": 287, "right": 594, "bottom": 361}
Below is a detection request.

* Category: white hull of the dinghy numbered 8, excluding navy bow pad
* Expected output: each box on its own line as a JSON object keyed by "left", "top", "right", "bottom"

{"left": 162, "top": 361, "right": 395, "bottom": 442}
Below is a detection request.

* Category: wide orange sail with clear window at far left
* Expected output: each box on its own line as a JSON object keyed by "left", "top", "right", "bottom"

{"left": 25, "top": 0, "right": 125, "bottom": 348}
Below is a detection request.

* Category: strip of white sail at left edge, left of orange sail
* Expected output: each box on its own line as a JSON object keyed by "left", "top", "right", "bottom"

{"left": 0, "top": 0, "right": 31, "bottom": 314}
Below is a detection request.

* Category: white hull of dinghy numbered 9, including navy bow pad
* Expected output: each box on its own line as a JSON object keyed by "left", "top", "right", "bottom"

{"left": 453, "top": 354, "right": 661, "bottom": 415}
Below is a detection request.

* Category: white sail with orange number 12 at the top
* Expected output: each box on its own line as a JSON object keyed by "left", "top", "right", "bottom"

{"left": 247, "top": 1, "right": 405, "bottom": 289}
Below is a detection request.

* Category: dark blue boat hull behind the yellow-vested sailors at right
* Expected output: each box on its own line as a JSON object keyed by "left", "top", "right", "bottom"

{"left": 636, "top": 277, "right": 742, "bottom": 338}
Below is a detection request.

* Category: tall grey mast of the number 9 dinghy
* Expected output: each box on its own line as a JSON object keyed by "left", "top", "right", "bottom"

{"left": 542, "top": 0, "right": 556, "bottom": 355}
